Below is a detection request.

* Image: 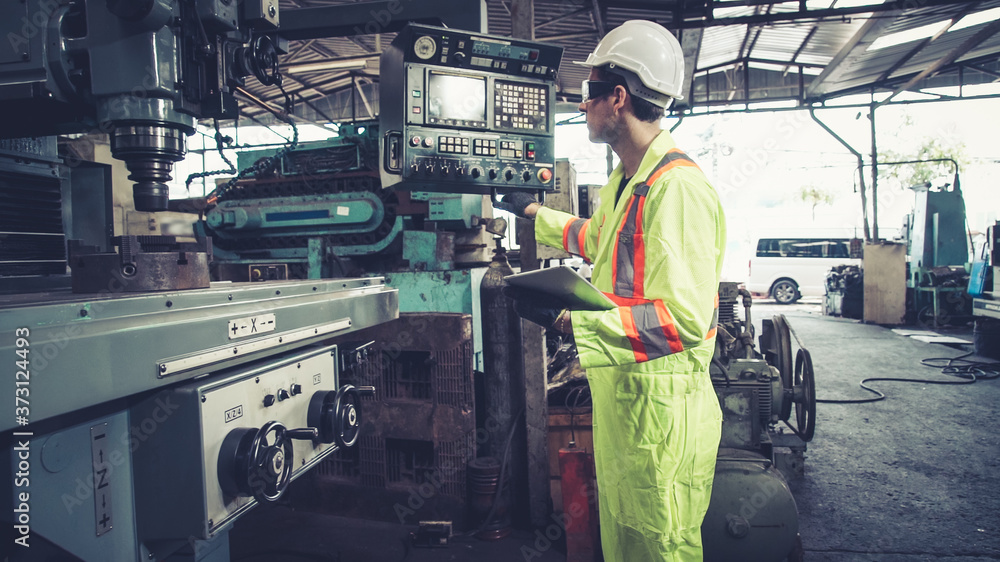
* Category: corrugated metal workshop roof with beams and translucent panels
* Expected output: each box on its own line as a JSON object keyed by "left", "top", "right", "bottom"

{"left": 236, "top": 0, "right": 1000, "bottom": 122}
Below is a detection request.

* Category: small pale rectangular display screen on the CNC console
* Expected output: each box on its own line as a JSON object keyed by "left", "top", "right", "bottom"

{"left": 427, "top": 72, "right": 486, "bottom": 128}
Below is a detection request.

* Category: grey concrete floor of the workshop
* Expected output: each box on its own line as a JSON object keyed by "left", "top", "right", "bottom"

{"left": 231, "top": 302, "right": 1000, "bottom": 562}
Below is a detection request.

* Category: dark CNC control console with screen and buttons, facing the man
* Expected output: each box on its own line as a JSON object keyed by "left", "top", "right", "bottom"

{"left": 380, "top": 24, "right": 562, "bottom": 194}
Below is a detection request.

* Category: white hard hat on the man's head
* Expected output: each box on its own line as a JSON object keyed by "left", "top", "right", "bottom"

{"left": 576, "top": 20, "right": 684, "bottom": 107}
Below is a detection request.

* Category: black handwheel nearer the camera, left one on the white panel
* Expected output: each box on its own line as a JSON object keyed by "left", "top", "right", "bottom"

{"left": 218, "top": 421, "right": 293, "bottom": 503}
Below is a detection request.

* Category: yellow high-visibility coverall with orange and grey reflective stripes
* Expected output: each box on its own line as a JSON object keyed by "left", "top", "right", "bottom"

{"left": 535, "top": 131, "right": 726, "bottom": 562}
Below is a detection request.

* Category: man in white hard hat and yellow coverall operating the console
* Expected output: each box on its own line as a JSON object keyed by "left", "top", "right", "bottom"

{"left": 498, "top": 21, "right": 725, "bottom": 562}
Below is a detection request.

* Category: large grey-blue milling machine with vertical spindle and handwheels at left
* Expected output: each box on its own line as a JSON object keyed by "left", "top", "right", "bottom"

{"left": 0, "top": 0, "right": 398, "bottom": 561}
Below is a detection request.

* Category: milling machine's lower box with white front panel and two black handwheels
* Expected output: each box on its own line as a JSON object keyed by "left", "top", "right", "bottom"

{"left": 132, "top": 346, "right": 373, "bottom": 541}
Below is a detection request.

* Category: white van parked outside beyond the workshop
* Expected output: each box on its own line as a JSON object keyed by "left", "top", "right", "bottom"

{"left": 746, "top": 234, "right": 861, "bottom": 304}
